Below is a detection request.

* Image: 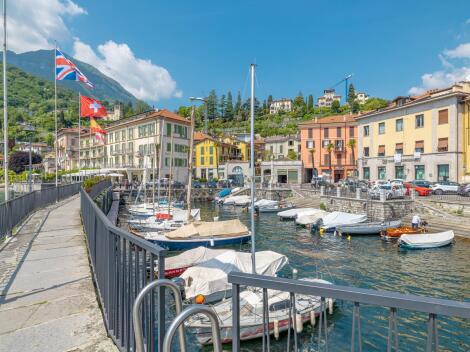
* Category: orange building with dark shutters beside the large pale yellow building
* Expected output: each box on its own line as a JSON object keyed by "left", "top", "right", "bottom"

{"left": 299, "top": 115, "right": 357, "bottom": 182}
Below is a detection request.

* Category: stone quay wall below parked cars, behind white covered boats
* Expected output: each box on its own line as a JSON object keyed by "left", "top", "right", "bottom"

{"left": 320, "top": 195, "right": 414, "bottom": 221}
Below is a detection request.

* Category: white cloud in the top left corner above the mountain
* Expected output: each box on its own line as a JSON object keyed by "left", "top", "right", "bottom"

{"left": 7, "top": 0, "right": 86, "bottom": 53}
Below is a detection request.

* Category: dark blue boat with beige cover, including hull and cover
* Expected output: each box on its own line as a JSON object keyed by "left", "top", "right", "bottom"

{"left": 143, "top": 219, "right": 251, "bottom": 251}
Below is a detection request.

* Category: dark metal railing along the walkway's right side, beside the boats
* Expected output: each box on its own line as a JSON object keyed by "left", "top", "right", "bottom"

{"left": 80, "top": 181, "right": 166, "bottom": 351}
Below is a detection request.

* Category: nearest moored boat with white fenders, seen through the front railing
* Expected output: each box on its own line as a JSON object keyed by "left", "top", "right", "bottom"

{"left": 186, "top": 279, "right": 333, "bottom": 344}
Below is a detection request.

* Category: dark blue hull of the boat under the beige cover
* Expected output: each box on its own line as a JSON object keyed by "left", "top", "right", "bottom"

{"left": 148, "top": 233, "right": 251, "bottom": 251}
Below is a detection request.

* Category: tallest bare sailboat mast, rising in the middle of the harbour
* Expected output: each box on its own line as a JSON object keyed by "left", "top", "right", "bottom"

{"left": 250, "top": 64, "right": 256, "bottom": 274}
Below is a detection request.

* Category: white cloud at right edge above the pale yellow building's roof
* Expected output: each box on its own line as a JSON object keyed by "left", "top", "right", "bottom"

{"left": 408, "top": 43, "right": 470, "bottom": 95}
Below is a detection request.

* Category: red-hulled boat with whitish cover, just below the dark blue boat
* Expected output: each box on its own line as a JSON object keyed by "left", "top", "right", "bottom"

{"left": 155, "top": 247, "right": 234, "bottom": 279}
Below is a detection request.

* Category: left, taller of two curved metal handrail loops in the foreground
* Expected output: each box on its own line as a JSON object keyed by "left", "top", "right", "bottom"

{"left": 132, "top": 279, "right": 186, "bottom": 352}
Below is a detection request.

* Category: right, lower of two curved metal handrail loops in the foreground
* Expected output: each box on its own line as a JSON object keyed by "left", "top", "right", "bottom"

{"left": 163, "top": 304, "right": 222, "bottom": 352}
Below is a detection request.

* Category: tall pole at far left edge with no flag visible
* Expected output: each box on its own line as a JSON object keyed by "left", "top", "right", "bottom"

{"left": 3, "top": 0, "right": 10, "bottom": 201}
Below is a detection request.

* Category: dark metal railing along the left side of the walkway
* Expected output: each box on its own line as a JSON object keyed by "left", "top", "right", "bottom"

{"left": 0, "top": 183, "right": 81, "bottom": 241}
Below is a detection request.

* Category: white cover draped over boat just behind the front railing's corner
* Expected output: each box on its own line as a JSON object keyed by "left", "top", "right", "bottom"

{"left": 180, "top": 251, "right": 289, "bottom": 298}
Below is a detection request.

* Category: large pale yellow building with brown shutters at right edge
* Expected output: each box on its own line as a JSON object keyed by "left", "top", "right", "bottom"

{"left": 357, "top": 82, "right": 470, "bottom": 182}
